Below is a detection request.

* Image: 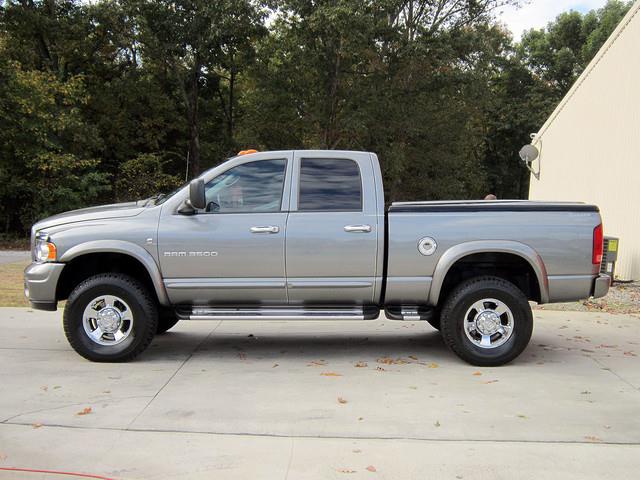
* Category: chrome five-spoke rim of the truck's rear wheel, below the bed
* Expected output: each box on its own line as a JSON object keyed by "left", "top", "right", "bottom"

{"left": 462, "top": 298, "right": 513, "bottom": 348}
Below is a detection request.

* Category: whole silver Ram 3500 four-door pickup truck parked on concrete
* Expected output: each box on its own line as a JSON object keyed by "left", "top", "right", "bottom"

{"left": 25, "top": 150, "right": 610, "bottom": 366}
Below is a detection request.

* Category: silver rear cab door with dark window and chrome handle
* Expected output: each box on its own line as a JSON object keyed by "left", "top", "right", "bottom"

{"left": 286, "top": 151, "right": 384, "bottom": 305}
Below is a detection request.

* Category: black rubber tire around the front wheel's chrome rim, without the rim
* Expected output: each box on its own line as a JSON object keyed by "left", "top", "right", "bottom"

{"left": 63, "top": 273, "right": 158, "bottom": 362}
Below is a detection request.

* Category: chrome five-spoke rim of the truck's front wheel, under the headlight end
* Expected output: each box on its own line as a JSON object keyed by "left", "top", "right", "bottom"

{"left": 82, "top": 295, "right": 133, "bottom": 345}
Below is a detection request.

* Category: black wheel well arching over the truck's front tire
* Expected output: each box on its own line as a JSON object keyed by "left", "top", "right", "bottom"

{"left": 56, "top": 252, "right": 157, "bottom": 300}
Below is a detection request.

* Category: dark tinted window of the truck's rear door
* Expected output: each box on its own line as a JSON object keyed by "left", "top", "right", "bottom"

{"left": 298, "top": 158, "right": 362, "bottom": 211}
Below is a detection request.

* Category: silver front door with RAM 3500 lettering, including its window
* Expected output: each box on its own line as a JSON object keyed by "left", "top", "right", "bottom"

{"left": 158, "top": 153, "right": 291, "bottom": 306}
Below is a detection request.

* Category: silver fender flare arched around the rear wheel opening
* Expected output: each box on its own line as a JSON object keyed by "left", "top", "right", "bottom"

{"left": 428, "top": 240, "right": 549, "bottom": 305}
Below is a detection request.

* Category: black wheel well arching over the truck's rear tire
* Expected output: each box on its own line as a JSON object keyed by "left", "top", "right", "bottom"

{"left": 438, "top": 252, "right": 540, "bottom": 303}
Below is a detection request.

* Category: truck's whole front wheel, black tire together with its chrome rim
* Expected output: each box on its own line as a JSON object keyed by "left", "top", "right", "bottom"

{"left": 63, "top": 273, "right": 158, "bottom": 362}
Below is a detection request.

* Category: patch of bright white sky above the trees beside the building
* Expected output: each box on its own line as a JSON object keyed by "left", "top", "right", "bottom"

{"left": 498, "top": 0, "right": 607, "bottom": 40}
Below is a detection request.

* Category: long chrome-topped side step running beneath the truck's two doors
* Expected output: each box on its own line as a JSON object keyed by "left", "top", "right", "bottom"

{"left": 176, "top": 306, "right": 380, "bottom": 320}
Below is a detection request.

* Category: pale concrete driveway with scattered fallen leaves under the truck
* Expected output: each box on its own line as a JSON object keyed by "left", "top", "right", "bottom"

{"left": 0, "top": 308, "right": 640, "bottom": 480}
